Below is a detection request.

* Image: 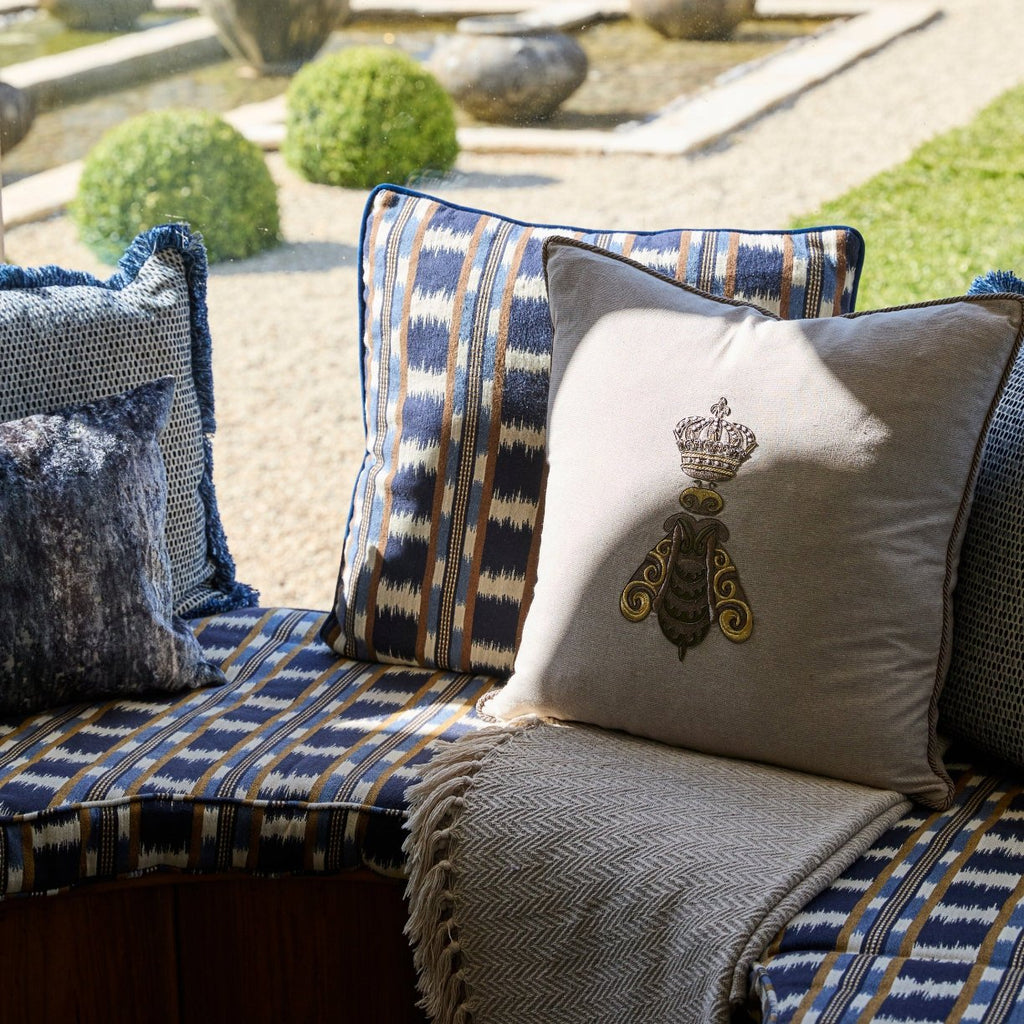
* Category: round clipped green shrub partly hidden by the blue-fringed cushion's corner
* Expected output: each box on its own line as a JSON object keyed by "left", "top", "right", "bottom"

{"left": 71, "top": 110, "right": 281, "bottom": 262}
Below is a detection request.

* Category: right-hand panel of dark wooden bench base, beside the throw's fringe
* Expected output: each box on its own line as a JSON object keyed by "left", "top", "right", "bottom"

{"left": 176, "top": 872, "right": 426, "bottom": 1024}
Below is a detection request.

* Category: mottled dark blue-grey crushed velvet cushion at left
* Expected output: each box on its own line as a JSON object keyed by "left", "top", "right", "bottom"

{"left": 0, "top": 378, "right": 223, "bottom": 715}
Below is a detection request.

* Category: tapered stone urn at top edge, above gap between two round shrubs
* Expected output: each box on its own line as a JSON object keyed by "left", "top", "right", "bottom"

{"left": 200, "top": 0, "right": 348, "bottom": 75}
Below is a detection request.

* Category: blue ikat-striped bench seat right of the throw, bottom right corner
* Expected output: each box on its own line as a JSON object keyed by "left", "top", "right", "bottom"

{"left": 753, "top": 767, "right": 1024, "bottom": 1024}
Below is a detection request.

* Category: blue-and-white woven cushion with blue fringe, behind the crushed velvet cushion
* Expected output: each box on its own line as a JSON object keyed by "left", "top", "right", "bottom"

{"left": 0, "top": 224, "right": 257, "bottom": 615}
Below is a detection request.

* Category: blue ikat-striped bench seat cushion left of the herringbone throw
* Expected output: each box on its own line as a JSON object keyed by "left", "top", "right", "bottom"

{"left": 0, "top": 608, "right": 494, "bottom": 896}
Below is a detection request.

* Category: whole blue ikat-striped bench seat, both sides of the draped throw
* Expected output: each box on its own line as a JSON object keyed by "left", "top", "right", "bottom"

{"left": 0, "top": 608, "right": 1024, "bottom": 1024}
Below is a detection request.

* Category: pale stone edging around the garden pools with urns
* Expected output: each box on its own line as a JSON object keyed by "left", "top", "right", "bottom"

{"left": 3, "top": 0, "right": 939, "bottom": 227}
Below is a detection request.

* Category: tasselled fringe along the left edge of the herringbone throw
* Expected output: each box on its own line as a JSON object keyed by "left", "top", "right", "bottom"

{"left": 402, "top": 718, "right": 541, "bottom": 1024}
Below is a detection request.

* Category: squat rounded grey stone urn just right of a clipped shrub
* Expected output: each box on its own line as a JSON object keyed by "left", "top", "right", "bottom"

{"left": 427, "top": 14, "right": 587, "bottom": 124}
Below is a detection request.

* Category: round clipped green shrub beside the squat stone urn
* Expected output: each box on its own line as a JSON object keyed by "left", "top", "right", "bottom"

{"left": 282, "top": 46, "right": 459, "bottom": 188}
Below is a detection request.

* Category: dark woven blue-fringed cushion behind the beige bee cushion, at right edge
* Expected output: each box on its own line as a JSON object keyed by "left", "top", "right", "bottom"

{"left": 939, "top": 271, "right": 1024, "bottom": 766}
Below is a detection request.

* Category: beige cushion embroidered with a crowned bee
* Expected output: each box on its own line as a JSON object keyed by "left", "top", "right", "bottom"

{"left": 484, "top": 240, "right": 1024, "bottom": 806}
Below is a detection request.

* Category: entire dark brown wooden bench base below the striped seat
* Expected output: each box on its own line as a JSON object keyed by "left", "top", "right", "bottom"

{"left": 0, "top": 871, "right": 426, "bottom": 1024}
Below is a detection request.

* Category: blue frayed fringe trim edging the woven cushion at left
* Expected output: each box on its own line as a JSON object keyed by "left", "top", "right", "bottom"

{"left": 0, "top": 223, "right": 259, "bottom": 617}
